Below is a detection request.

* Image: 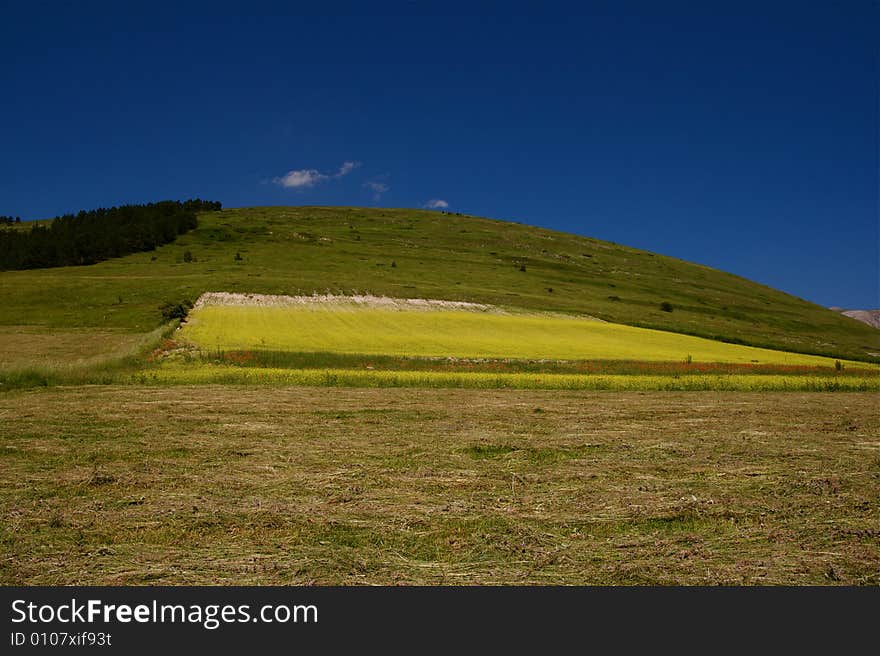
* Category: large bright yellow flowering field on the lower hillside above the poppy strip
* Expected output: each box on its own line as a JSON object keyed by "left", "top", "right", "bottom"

{"left": 179, "top": 305, "right": 864, "bottom": 366}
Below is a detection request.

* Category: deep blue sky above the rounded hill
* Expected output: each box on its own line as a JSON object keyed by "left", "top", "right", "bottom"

{"left": 0, "top": 0, "right": 880, "bottom": 307}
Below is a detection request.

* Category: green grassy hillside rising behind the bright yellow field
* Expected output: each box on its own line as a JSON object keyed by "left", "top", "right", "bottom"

{"left": 0, "top": 207, "right": 880, "bottom": 361}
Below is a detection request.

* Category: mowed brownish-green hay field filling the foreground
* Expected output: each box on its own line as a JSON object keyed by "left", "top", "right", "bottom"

{"left": 0, "top": 386, "right": 880, "bottom": 585}
